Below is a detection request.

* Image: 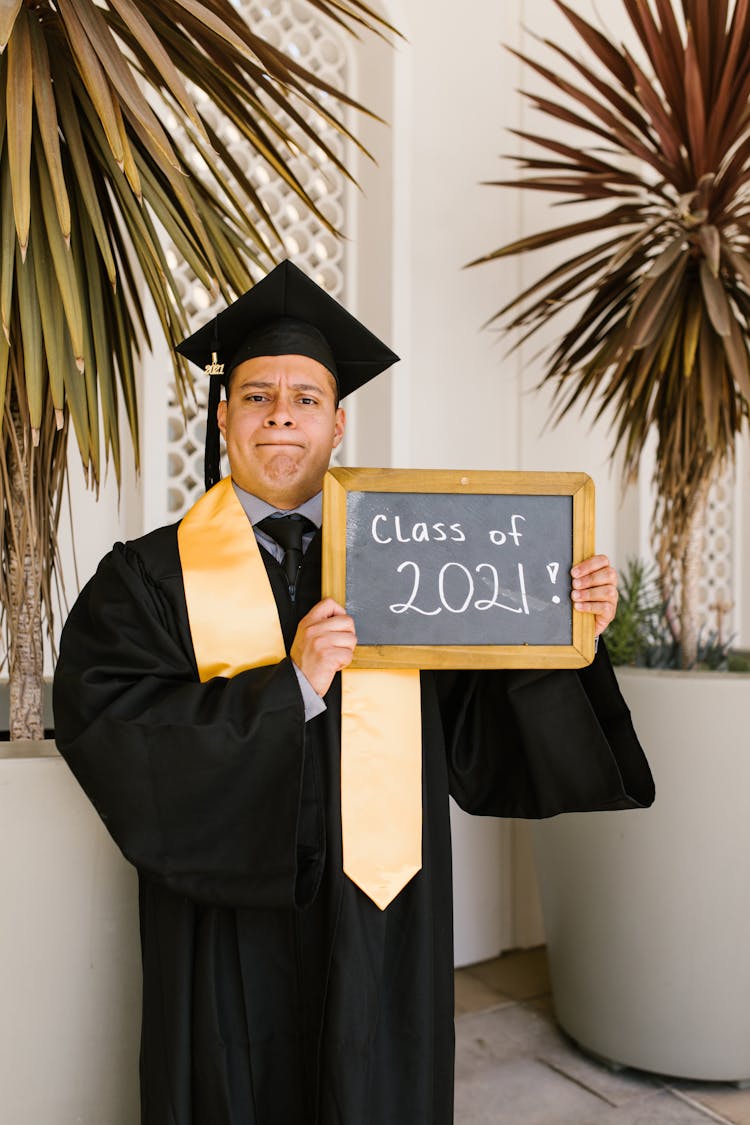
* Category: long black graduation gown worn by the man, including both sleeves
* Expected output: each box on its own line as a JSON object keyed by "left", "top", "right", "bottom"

{"left": 54, "top": 525, "right": 653, "bottom": 1125}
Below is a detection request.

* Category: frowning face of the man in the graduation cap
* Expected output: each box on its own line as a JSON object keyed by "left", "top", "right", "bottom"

{"left": 218, "top": 356, "right": 345, "bottom": 511}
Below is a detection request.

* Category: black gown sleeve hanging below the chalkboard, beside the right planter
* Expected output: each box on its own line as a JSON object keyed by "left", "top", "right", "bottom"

{"left": 439, "top": 641, "right": 654, "bottom": 819}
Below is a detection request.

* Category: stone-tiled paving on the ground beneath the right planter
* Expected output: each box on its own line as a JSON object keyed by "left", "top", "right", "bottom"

{"left": 455, "top": 950, "right": 750, "bottom": 1125}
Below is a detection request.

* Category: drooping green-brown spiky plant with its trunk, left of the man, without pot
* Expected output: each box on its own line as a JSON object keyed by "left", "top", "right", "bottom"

{"left": 0, "top": 0, "right": 388, "bottom": 738}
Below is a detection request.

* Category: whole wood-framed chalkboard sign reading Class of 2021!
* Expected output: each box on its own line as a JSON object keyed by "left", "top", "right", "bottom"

{"left": 323, "top": 469, "right": 594, "bottom": 668}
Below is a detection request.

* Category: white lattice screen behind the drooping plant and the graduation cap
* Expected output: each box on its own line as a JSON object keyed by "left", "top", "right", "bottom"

{"left": 166, "top": 0, "right": 350, "bottom": 520}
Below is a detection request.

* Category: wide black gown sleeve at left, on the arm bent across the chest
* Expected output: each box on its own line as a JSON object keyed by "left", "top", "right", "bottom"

{"left": 54, "top": 545, "right": 323, "bottom": 907}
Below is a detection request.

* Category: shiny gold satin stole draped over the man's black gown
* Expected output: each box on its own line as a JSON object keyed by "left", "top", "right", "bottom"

{"left": 178, "top": 477, "right": 422, "bottom": 910}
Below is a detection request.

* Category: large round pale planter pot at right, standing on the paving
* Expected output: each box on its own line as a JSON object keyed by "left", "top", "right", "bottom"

{"left": 534, "top": 668, "right": 750, "bottom": 1081}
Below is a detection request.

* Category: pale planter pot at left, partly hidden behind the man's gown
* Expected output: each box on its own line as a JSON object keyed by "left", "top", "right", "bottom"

{"left": 0, "top": 741, "right": 141, "bottom": 1125}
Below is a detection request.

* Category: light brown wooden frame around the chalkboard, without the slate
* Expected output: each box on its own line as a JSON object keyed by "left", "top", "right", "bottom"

{"left": 323, "top": 468, "right": 595, "bottom": 668}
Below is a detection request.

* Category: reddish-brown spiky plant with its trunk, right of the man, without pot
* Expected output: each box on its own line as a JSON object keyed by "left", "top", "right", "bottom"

{"left": 480, "top": 0, "right": 750, "bottom": 667}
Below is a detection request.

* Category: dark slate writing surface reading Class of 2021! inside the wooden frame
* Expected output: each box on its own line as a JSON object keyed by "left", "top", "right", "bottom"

{"left": 344, "top": 491, "right": 573, "bottom": 647}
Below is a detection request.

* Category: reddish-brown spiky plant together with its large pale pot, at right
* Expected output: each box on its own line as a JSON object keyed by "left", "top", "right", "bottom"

{"left": 474, "top": 0, "right": 750, "bottom": 1080}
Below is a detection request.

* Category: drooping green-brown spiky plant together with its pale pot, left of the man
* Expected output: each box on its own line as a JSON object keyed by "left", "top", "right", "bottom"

{"left": 0, "top": 0, "right": 395, "bottom": 1123}
